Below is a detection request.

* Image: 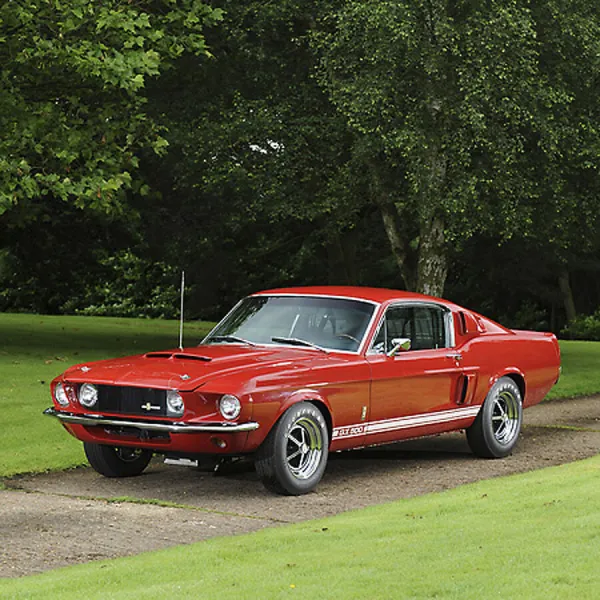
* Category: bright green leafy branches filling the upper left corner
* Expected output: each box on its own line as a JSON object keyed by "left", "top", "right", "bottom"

{"left": 0, "top": 0, "right": 221, "bottom": 218}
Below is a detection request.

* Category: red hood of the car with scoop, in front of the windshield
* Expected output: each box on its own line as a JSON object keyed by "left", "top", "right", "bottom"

{"left": 63, "top": 344, "right": 342, "bottom": 392}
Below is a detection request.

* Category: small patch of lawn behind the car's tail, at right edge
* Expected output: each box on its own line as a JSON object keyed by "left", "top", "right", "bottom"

{"left": 548, "top": 341, "right": 600, "bottom": 398}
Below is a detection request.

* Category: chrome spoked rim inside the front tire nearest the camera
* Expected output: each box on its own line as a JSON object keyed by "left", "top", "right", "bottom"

{"left": 286, "top": 418, "right": 323, "bottom": 479}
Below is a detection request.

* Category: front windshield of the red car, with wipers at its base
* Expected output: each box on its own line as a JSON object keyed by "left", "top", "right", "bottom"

{"left": 203, "top": 296, "right": 375, "bottom": 352}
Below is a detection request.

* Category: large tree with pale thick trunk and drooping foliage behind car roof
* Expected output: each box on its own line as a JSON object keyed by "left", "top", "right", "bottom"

{"left": 314, "top": 0, "right": 598, "bottom": 295}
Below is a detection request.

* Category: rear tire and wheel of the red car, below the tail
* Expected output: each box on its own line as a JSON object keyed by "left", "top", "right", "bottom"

{"left": 467, "top": 377, "right": 523, "bottom": 458}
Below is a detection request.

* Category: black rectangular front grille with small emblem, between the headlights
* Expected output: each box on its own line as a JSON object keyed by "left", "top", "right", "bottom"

{"left": 98, "top": 385, "right": 167, "bottom": 417}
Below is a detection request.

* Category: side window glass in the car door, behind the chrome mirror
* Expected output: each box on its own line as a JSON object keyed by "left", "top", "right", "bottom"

{"left": 372, "top": 305, "right": 449, "bottom": 354}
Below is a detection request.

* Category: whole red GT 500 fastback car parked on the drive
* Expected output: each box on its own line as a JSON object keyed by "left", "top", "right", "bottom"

{"left": 45, "top": 287, "right": 560, "bottom": 495}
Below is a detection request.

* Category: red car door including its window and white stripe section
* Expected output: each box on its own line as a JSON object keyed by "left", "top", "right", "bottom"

{"left": 366, "top": 302, "right": 473, "bottom": 444}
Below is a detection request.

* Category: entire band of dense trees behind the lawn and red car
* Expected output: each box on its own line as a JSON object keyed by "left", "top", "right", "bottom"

{"left": 0, "top": 0, "right": 600, "bottom": 329}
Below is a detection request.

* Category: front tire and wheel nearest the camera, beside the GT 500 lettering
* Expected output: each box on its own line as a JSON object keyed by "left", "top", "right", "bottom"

{"left": 254, "top": 402, "right": 329, "bottom": 496}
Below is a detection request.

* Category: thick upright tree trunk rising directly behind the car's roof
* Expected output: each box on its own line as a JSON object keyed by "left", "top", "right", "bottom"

{"left": 416, "top": 217, "right": 448, "bottom": 297}
